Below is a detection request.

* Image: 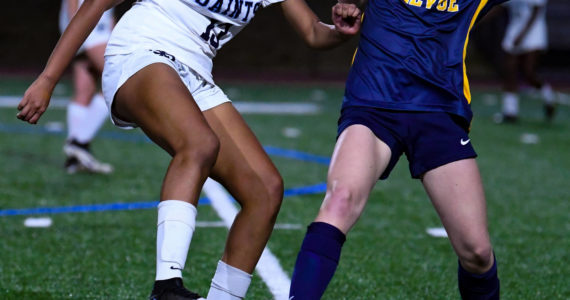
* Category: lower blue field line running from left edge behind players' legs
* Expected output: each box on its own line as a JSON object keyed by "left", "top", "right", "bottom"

{"left": 0, "top": 182, "right": 327, "bottom": 217}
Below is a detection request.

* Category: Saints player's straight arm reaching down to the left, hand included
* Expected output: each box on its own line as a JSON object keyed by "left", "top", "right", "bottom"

{"left": 17, "top": 0, "right": 123, "bottom": 124}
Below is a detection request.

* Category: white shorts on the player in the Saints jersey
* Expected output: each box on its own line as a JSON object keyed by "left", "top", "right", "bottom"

{"left": 102, "top": 49, "right": 231, "bottom": 129}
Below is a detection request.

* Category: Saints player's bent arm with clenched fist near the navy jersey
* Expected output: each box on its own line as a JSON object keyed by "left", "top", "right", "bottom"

{"left": 281, "top": 0, "right": 361, "bottom": 49}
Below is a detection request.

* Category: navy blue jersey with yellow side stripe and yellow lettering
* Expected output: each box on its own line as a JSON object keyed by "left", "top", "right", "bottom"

{"left": 343, "top": 0, "right": 504, "bottom": 122}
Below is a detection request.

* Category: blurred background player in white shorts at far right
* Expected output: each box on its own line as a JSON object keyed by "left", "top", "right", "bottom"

{"left": 502, "top": 0, "right": 555, "bottom": 122}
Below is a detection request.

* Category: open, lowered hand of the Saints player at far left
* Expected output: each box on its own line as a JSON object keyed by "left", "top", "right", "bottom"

{"left": 16, "top": 75, "right": 55, "bottom": 124}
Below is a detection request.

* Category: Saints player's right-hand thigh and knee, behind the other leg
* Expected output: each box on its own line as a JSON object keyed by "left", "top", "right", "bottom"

{"left": 204, "top": 102, "right": 283, "bottom": 204}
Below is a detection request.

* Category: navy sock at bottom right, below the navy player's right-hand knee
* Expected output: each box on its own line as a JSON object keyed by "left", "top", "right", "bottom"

{"left": 457, "top": 255, "right": 500, "bottom": 300}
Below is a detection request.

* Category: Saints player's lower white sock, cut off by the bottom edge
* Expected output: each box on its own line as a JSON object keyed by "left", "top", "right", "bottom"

{"left": 208, "top": 261, "right": 251, "bottom": 300}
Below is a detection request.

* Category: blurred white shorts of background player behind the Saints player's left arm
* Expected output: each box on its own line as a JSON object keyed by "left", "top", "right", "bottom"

{"left": 59, "top": 0, "right": 115, "bottom": 53}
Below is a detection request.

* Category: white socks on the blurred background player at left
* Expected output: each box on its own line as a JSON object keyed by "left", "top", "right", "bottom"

{"left": 67, "top": 94, "right": 109, "bottom": 143}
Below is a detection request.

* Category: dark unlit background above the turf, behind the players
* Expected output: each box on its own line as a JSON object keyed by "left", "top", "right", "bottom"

{"left": 0, "top": 0, "right": 570, "bottom": 86}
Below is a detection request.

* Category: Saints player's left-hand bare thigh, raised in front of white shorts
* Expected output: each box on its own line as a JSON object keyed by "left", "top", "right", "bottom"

{"left": 112, "top": 63, "right": 215, "bottom": 155}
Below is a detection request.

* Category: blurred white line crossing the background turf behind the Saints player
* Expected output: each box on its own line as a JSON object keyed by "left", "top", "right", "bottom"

{"left": 0, "top": 96, "right": 321, "bottom": 115}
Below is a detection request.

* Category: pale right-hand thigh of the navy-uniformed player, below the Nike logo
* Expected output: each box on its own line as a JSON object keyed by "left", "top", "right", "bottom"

{"left": 422, "top": 158, "right": 490, "bottom": 254}
